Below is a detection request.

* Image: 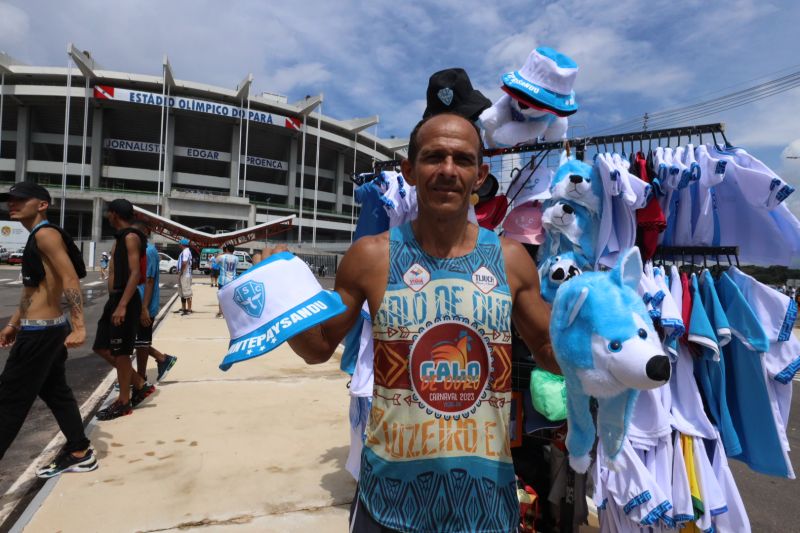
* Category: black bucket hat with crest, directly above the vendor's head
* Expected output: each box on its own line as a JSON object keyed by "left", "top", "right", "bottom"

{"left": 422, "top": 68, "right": 492, "bottom": 122}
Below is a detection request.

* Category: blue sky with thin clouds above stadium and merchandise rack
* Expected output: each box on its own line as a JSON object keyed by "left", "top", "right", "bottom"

{"left": 0, "top": 0, "right": 800, "bottom": 214}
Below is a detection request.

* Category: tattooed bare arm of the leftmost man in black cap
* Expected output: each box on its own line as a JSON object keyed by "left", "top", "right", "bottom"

{"left": 36, "top": 228, "right": 86, "bottom": 348}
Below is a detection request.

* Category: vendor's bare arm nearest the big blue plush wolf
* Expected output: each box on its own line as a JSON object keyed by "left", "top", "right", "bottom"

{"left": 501, "top": 238, "right": 561, "bottom": 374}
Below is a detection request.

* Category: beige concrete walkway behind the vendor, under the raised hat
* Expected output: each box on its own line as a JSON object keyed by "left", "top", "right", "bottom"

{"left": 14, "top": 285, "right": 355, "bottom": 533}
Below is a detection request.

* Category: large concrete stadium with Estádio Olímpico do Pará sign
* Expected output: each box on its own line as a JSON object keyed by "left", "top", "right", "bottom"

{"left": 0, "top": 45, "right": 407, "bottom": 255}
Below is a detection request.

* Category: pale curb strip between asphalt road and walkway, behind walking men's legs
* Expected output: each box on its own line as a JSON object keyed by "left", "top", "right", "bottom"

{"left": 0, "top": 291, "right": 178, "bottom": 533}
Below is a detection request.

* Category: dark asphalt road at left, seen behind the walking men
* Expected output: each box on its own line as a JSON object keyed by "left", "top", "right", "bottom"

{"left": 0, "top": 266, "right": 176, "bottom": 508}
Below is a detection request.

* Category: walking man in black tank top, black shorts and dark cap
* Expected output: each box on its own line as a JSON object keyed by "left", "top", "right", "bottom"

{"left": 92, "top": 198, "right": 155, "bottom": 420}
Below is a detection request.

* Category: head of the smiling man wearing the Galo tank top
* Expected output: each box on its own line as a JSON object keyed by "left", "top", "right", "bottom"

{"left": 403, "top": 115, "right": 489, "bottom": 217}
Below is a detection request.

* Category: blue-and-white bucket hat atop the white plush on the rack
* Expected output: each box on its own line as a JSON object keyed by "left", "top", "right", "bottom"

{"left": 503, "top": 47, "right": 578, "bottom": 116}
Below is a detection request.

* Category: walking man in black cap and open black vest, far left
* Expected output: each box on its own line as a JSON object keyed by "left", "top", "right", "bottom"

{"left": 0, "top": 182, "right": 97, "bottom": 477}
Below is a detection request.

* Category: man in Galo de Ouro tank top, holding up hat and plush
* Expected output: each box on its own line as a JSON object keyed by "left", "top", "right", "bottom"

{"left": 289, "top": 113, "right": 561, "bottom": 533}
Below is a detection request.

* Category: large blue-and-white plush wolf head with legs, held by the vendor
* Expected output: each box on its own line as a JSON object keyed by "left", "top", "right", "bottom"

{"left": 550, "top": 247, "right": 671, "bottom": 473}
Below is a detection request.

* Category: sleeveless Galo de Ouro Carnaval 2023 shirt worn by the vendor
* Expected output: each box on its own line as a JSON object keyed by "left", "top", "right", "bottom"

{"left": 359, "top": 224, "right": 519, "bottom": 533}
